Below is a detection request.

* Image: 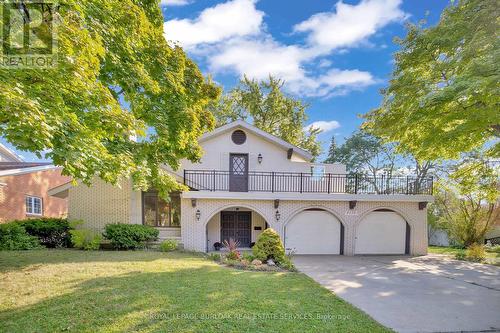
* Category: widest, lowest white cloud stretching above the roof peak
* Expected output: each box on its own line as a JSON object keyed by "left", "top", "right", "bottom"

{"left": 208, "top": 38, "right": 376, "bottom": 97}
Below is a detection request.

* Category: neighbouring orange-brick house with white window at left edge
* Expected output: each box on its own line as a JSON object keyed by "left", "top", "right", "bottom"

{"left": 0, "top": 144, "right": 71, "bottom": 223}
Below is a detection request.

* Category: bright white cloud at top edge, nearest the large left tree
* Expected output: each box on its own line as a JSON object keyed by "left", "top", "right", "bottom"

{"left": 163, "top": 0, "right": 264, "bottom": 49}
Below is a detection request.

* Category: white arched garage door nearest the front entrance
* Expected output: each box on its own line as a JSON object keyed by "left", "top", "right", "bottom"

{"left": 285, "top": 210, "right": 341, "bottom": 254}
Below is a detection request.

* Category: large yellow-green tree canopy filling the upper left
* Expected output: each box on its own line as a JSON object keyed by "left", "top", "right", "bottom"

{"left": 0, "top": 0, "right": 219, "bottom": 195}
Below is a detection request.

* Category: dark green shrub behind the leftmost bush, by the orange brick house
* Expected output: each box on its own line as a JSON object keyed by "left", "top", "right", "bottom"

{"left": 11, "top": 217, "right": 72, "bottom": 247}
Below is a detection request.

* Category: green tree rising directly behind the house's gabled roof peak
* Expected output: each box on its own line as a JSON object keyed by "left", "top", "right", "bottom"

{"left": 211, "top": 76, "right": 321, "bottom": 156}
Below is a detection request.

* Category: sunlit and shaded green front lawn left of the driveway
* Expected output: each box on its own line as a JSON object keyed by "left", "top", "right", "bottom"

{"left": 0, "top": 250, "right": 388, "bottom": 332}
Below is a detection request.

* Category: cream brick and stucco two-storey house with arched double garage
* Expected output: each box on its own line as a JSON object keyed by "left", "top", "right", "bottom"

{"left": 50, "top": 121, "right": 432, "bottom": 255}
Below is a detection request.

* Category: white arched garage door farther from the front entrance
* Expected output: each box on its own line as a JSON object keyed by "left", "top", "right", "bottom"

{"left": 355, "top": 211, "right": 406, "bottom": 254}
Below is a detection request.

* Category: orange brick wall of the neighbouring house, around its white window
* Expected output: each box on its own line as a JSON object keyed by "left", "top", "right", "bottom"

{"left": 0, "top": 169, "right": 71, "bottom": 223}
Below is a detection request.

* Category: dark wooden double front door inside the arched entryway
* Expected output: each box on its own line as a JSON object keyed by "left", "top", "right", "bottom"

{"left": 220, "top": 212, "right": 252, "bottom": 247}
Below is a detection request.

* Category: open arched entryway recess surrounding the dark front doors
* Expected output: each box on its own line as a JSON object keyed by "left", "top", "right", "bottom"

{"left": 206, "top": 207, "right": 268, "bottom": 251}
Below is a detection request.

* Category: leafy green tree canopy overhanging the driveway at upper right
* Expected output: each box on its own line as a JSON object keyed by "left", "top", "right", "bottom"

{"left": 364, "top": 0, "right": 500, "bottom": 160}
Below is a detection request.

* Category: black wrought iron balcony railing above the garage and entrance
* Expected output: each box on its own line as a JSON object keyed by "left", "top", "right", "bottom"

{"left": 184, "top": 170, "right": 433, "bottom": 195}
